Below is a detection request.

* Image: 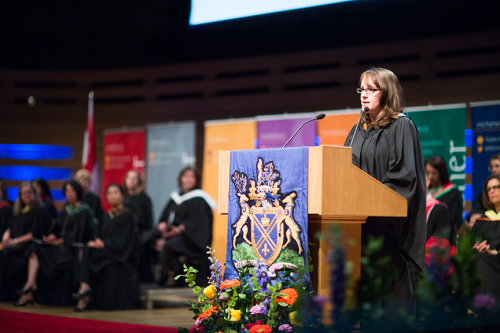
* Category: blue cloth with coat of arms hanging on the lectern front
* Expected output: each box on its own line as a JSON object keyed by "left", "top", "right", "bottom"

{"left": 224, "top": 147, "right": 309, "bottom": 279}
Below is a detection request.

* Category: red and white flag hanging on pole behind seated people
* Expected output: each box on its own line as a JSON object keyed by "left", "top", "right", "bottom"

{"left": 82, "top": 91, "right": 99, "bottom": 193}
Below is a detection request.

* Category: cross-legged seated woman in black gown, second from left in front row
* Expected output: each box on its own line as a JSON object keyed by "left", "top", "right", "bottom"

{"left": 14, "top": 180, "right": 94, "bottom": 306}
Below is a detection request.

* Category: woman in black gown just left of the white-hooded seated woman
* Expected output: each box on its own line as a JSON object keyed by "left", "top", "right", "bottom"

{"left": 123, "top": 170, "right": 154, "bottom": 282}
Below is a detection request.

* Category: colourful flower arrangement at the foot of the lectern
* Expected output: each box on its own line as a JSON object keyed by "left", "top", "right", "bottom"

{"left": 176, "top": 248, "right": 307, "bottom": 333}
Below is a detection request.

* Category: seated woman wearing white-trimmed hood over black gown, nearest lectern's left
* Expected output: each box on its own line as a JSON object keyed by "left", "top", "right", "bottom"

{"left": 146, "top": 167, "right": 217, "bottom": 286}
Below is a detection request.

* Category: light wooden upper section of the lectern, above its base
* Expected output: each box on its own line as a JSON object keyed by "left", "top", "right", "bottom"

{"left": 218, "top": 146, "right": 407, "bottom": 221}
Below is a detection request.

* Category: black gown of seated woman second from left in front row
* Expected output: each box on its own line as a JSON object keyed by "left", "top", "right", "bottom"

{"left": 35, "top": 203, "right": 94, "bottom": 306}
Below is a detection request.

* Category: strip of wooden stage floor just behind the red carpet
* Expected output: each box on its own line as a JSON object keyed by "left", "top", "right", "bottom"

{"left": 0, "top": 302, "right": 194, "bottom": 328}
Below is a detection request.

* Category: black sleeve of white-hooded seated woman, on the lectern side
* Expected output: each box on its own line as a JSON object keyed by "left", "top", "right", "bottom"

{"left": 182, "top": 198, "right": 213, "bottom": 251}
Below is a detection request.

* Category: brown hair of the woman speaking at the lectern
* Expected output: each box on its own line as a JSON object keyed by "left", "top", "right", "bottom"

{"left": 359, "top": 67, "right": 404, "bottom": 129}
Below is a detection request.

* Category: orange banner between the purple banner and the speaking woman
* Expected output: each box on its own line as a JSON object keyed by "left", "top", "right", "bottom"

{"left": 318, "top": 110, "right": 359, "bottom": 146}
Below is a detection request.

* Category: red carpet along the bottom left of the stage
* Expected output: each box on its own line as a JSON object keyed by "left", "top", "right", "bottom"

{"left": 0, "top": 310, "right": 177, "bottom": 333}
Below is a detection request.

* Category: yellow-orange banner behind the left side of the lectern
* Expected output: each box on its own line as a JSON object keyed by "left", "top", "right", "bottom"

{"left": 202, "top": 118, "right": 257, "bottom": 263}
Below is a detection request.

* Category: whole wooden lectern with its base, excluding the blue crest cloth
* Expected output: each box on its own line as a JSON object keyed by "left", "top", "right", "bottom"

{"left": 216, "top": 146, "right": 407, "bottom": 296}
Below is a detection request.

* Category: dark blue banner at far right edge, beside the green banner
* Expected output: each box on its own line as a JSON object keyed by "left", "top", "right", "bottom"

{"left": 471, "top": 101, "right": 500, "bottom": 203}
